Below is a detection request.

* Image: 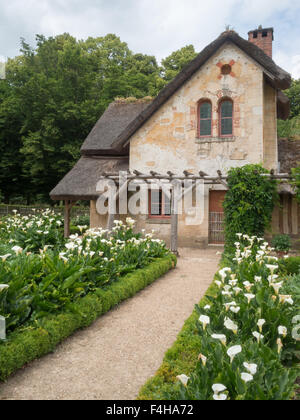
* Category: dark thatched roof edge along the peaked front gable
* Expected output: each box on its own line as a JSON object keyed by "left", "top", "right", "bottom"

{"left": 112, "top": 31, "right": 291, "bottom": 151}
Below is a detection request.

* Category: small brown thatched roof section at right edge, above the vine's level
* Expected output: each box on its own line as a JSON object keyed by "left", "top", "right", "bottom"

{"left": 278, "top": 139, "right": 300, "bottom": 173}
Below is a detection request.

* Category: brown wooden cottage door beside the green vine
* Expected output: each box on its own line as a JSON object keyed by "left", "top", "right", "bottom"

{"left": 209, "top": 191, "right": 226, "bottom": 244}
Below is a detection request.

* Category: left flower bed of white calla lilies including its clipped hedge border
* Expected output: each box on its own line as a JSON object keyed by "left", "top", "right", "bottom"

{"left": 0, "top": 210, "right": 176, "bottom": 380}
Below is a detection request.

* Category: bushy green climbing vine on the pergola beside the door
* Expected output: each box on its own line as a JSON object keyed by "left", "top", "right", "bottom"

{"left": 224, "top": 165, "right": 278, "bottom": 251}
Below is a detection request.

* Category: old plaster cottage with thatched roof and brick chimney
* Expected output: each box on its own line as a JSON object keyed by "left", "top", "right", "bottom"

{"left": 50, "top": 27, "right": 300, "bottom": 247}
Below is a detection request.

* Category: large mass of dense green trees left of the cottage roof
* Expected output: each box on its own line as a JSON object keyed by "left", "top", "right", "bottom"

{"left": 0, "top": 34, "right": 166, "bottom": 203}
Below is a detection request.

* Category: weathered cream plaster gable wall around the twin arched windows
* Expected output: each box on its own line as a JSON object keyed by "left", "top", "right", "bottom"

{"left": 130, "top": 44, "right": 263, "bottom": 174}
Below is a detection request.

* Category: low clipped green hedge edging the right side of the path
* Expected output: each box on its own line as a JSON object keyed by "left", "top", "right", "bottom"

{"left": 138, "top": 282, "right": 218, "bottom": 400}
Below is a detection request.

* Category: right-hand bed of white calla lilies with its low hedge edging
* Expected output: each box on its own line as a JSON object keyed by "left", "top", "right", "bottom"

{"left": 139, "top": 235, "right": 300, "bottom": 400}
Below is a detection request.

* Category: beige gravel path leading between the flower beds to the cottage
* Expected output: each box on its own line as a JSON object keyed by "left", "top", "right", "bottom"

{"left": 0, "top": 248, "right": 219, "bottom": 400}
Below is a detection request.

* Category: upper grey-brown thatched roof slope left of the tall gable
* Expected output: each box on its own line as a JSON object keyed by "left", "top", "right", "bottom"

{"left": 81, "top": 98, "right": 152, "bottom": 155}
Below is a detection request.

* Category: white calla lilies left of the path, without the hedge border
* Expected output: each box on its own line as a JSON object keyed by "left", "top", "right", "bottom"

{"left": 0, "top": 211, "right": 169, "bottom": 337}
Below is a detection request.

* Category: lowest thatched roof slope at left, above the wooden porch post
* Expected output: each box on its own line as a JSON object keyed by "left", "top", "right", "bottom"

{"left": 50, "top": 156, "right": 129, "bottom": 200}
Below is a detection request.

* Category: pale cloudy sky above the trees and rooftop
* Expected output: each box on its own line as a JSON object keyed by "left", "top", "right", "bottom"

{"left": 0, "top": 0, "right": 300, "bottom": 79}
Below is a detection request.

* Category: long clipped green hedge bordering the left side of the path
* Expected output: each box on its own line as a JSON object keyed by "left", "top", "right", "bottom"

{"left": 0, "top": 255, "right": 177, "bottom": 381}
